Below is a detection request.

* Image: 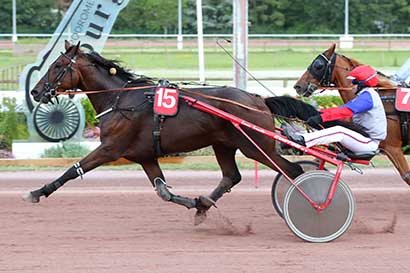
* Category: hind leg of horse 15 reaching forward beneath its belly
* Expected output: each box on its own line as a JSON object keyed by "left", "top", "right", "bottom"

{"left": 195, "top": 145, "right": 241, "bottom": 225}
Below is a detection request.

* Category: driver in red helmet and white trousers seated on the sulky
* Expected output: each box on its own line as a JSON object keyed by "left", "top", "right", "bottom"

{"left": 285, "top": 65, "right": 387, "bottom": 153}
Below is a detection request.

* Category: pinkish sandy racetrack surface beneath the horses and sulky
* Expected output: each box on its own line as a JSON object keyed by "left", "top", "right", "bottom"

{"left": 0, "top": 169, "right": 410, "bottom": 273}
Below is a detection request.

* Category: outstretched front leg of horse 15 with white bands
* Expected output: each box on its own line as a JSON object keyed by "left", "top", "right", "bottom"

{"left": 23, "top": 144, "right": 120, "bottom": 203}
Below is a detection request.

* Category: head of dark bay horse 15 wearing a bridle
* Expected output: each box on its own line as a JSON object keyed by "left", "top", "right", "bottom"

{"left": 30, "top": 41, "right": 82, "bottom": 103}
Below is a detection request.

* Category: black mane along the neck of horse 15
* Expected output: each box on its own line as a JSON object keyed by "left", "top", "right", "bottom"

{"left": 86, "top": 51, "right": 153, "bottom": 84}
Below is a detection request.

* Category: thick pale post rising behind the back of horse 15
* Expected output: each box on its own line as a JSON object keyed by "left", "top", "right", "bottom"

{"left": 233, "top": 0, "right": 248, "bottom": 90}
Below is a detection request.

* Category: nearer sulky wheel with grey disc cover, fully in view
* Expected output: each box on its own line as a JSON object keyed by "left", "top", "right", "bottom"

{"left": 283, "top": 170, "right": 355, "bottom": 243}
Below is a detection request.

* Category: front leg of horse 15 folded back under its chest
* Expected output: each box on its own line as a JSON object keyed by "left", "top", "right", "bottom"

{"left": 141, "top": 160, "right": 198, "bottom": 209}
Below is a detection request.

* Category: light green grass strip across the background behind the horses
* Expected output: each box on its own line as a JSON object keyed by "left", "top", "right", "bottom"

{"left": 0, "top": 39, "right": 409, "bottom": 72}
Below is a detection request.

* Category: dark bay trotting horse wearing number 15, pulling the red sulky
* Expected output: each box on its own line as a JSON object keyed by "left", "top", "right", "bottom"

{"left": 23, "top": 42, "right": 303, "bottom": 224}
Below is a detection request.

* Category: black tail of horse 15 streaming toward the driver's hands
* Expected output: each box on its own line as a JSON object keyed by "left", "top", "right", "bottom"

{"left": 265, "top": 96, "right": 319, "bottom": 120}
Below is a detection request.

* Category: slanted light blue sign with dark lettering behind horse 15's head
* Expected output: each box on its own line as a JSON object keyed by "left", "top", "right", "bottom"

{"left": 20, "top": 0, "right": 129, "bottom": 112}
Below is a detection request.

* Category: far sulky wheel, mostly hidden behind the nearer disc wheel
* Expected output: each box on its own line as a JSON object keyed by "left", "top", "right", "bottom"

{"left": 271, "top": 160, "right": 326, "bottom": 218}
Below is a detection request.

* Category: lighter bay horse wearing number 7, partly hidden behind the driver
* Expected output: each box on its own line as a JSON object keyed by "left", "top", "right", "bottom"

{"left": 294, "top": 44, "right": 410, "bottom": 185}
